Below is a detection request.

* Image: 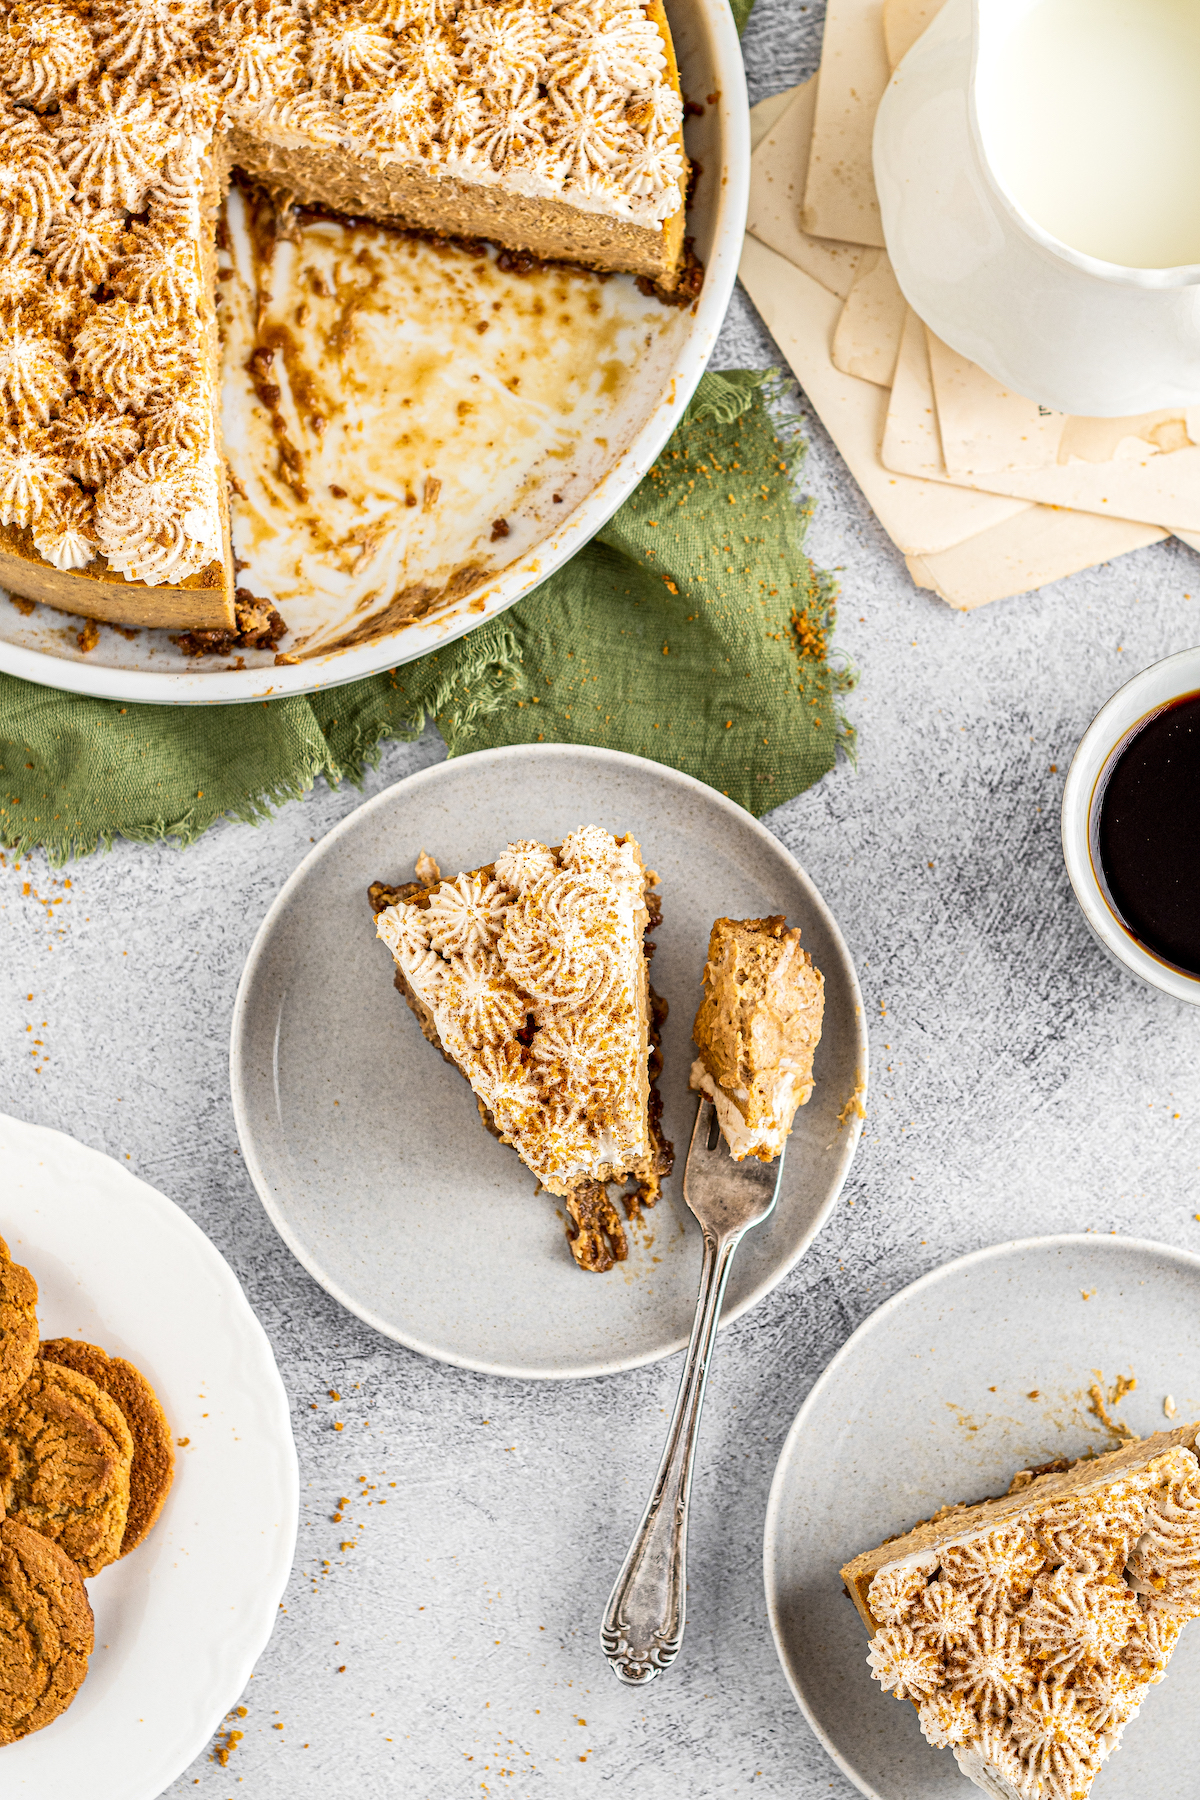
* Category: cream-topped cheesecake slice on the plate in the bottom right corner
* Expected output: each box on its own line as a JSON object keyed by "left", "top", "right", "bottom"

{"left": 842, "top": 1424, "right": 1200, "bottom": 1800}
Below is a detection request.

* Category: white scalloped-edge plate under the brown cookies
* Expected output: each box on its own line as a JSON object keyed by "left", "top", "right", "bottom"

{"left": 0, "top": 1116, "right": 299, "bottom": 1800}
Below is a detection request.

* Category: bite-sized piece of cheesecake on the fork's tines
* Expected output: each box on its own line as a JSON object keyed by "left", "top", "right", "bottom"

{"left": 691, "top": 916, "right": 826, "bottom": 1163}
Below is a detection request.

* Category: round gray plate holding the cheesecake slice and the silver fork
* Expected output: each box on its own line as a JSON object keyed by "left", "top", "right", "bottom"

{"left": 232, "top": 743, "right": 867, "bottom": 1377}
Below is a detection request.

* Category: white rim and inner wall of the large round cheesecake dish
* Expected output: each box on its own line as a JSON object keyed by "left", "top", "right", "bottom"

{"left": 0, "top": 0, "right": 750, "bottom": 706}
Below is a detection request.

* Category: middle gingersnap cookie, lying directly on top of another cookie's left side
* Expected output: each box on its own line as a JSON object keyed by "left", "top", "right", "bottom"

{"left": 0, "top": 1359, "right": 133, "bottom": 1575}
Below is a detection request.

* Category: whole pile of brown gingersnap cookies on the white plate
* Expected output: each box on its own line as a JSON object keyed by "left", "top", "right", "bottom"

{"left": 0, "top": 1238, "right": 175, "bottom": 1744}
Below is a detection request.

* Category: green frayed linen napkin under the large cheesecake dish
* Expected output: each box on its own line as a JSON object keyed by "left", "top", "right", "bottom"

{"left": 0, "top": 371, "right": 853, "bottom": 862}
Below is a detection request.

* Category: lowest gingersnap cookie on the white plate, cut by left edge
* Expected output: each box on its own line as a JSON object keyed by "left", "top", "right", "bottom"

{"left": 0, "top": 1519, "right": 94, "bottom": 1744}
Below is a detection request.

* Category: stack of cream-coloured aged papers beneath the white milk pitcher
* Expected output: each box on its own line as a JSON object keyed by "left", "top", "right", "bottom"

{"left": 741, "top": 0, "right": 1200, "bottom": 607}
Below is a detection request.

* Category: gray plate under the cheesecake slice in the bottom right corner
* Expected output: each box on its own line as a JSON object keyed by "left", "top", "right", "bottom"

{"left": 765, "top": 1237, "right": 1200, "bottom": 1800}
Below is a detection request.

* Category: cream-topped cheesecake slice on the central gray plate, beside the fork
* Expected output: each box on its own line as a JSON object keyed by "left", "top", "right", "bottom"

{"left": 371, "top": 824, "right": 671, "bottom": 1271}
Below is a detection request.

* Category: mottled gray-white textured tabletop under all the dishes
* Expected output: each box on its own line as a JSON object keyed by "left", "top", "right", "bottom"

{"left": 0, "top": 0, "right": 1200, "bottom": 1800}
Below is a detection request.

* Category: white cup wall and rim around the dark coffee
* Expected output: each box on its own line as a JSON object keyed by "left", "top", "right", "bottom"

{"left": 1063, "top": 646, "right": 1200, "bottom": 1006}
